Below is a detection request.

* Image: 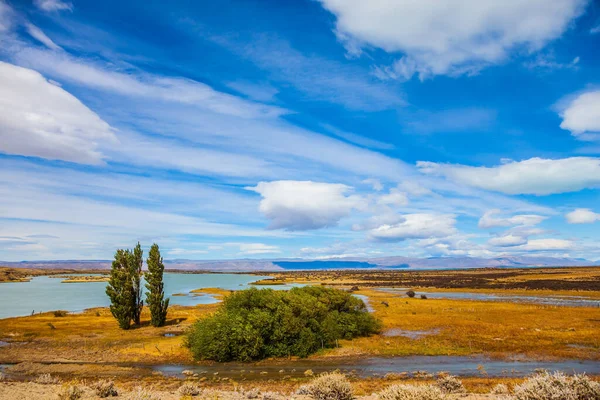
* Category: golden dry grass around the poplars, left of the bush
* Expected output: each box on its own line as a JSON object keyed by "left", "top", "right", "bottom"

{"left": 0, "top": 305, "right": 216, "bottom": 363}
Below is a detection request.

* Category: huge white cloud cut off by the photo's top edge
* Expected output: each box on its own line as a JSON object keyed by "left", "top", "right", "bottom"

{"left": 320, "top": 0, "right": 587, "bottom": 79}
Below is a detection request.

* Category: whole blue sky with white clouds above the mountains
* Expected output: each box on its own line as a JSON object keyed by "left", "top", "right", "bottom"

{"left": 0, "top": 0, "right": 600, "bottom": 261}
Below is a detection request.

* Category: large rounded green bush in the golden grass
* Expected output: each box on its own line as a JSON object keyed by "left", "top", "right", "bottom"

{"left": 186, "top": 287, "right": 380, "bottom": 361}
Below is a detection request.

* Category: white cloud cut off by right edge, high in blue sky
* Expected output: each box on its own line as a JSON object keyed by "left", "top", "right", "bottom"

{"left": 560, "top": 90, "right": 600, "bottom": 140}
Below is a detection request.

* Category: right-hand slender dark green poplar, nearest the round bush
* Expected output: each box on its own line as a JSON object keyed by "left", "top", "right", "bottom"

{"left": 145, "top": 243, "right": 169, "bottom": 326}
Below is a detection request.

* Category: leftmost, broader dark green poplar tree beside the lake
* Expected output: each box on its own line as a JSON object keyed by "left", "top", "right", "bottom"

{"left": 106, "top": 249, "right": 133, "bottom": 329}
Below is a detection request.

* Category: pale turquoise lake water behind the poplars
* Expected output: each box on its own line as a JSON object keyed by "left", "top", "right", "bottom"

{"left": 0, "top": 273, "right": 302, "bottom": 318}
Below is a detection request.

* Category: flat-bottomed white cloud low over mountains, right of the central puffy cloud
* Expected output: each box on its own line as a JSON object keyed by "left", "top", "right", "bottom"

{"left": 369, "top": 213, "right": 457, "bottom": 241}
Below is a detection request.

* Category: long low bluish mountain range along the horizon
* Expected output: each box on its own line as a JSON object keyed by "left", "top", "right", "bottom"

{"left": 0, "top": 256, "right": 598, "bottom": 272}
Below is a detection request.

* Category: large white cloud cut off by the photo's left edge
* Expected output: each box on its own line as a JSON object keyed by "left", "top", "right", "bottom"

{"left": 0, "top": 62, "right": 116, "bottom": 164}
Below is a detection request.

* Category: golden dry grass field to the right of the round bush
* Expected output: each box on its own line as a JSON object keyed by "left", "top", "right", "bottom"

{"left": 329, "top": 290, "right": 600, "bottom": 359}
